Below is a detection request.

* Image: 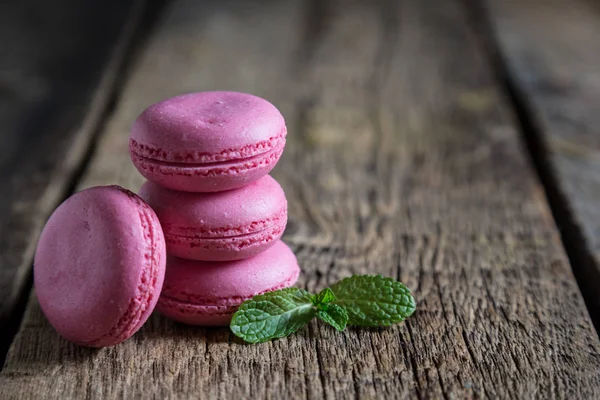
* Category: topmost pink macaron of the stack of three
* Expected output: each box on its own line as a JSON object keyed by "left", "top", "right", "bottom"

{"left": 129, "top": 92, "right": 287, "bottom": 192}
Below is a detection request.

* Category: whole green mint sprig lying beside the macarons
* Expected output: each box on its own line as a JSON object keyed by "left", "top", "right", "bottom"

{"left": 230, "top": 275, "right": 415, "bottom": 343}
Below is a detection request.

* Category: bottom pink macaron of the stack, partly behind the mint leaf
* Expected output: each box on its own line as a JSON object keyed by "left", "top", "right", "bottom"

{"left": 156, "top": 241, "right": 300, "bottom": 326}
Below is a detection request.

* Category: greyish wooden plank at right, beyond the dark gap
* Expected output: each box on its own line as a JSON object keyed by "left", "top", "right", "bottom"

{"left": 480, "top": 0, "right": 600, "bottom": 329}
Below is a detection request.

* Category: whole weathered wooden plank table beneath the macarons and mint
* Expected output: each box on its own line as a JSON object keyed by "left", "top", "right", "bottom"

{"left": 0, "top": 0, "right": 600, "bottom": 399}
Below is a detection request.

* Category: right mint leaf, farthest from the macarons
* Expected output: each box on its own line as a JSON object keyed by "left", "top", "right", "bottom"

{"left": 330, "top": 275, "right": 415, "bottom": 326}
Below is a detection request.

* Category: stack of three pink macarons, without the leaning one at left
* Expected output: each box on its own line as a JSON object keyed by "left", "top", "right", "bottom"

{"left": 129, "top": 92, "right": 300, "bottom": 326}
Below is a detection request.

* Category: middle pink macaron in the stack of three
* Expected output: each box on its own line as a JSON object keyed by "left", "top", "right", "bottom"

{"left": 139, "top": 175, "right": 287, "bottom": 261}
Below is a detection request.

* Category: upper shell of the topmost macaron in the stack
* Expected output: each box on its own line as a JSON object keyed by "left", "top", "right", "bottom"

{"left": 131, "top": 92, "right": 287, "bottom": 164}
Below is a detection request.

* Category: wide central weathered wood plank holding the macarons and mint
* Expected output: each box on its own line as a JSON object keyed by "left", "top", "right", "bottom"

{"left": 0, "top": 0, "right": 600, "bottom": 399}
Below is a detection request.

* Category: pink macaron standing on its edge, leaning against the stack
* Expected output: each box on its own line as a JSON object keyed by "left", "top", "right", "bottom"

{"left": 34, "top": 186, "right": 166, "bottom": 347}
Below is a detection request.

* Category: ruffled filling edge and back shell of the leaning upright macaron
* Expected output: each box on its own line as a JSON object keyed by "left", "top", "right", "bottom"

{"left": 84, "top": 186, "right": 160, "bottom": 347}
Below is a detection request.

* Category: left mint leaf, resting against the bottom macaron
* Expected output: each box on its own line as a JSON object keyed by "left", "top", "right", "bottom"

{"left": 229, "top": 288, "right": 316, "bottom": 343}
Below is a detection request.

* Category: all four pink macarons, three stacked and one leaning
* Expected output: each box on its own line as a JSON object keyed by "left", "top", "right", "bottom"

{"left": 34, "top": 92, "right": 300, "bottom": 347}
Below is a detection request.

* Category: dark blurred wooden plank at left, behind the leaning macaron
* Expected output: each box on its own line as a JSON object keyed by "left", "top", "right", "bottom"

{"left": 0, "top": 0, "right": 140, "bottom": 365}
